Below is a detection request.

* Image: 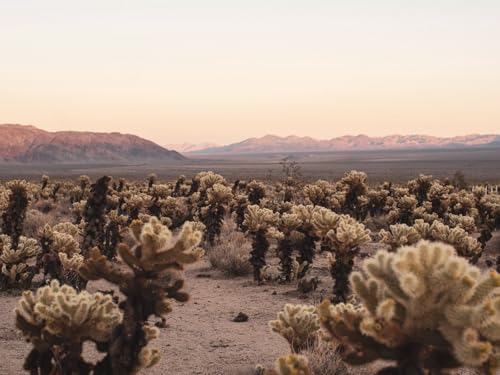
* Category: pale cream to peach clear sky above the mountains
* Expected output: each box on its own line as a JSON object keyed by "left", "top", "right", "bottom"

{"left": 0, "top": 0, "right": 500, "bottom": 144}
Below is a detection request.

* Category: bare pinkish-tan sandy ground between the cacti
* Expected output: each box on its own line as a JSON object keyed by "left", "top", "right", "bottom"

{"left": 0, "top": 232, "right": 500, "bottom": 375}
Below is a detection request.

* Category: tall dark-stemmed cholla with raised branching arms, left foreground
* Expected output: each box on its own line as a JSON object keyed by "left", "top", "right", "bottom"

{"left": 80, "top": 217, "right": 203, "bottom": 375}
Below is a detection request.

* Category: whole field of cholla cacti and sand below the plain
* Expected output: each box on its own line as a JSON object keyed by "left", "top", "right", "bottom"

{"left": 0, "top": 173, "right": 500, "bottom": 375}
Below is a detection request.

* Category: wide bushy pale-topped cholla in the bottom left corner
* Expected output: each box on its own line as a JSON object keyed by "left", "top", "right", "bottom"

{"left": 16, "top": 280, "right": 123, "bottom": 374}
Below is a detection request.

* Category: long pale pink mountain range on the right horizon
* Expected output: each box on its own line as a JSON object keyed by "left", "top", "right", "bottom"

{"left": 193, "top": 134, "right": 500, "bottom": 154}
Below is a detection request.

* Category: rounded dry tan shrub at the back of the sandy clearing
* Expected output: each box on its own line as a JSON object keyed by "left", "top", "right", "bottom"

{"left": 207, "top": 222, "right": 252, "bottom": 276}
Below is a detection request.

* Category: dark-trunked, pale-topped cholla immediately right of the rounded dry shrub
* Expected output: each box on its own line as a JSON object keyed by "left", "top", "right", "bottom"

{"left": 243, "top": 205, "right": 279, "bottom": 283}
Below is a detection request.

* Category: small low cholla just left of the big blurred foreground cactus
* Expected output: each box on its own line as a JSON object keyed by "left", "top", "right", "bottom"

{"left": 269, "top": 304, "right": 319, "bottom": 353}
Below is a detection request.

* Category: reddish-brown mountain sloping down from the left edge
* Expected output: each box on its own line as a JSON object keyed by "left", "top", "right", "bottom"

{"left": 0, "top": 124, "right": 186, "bottom": 163}
